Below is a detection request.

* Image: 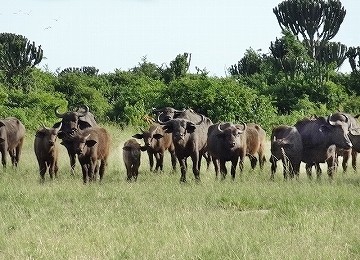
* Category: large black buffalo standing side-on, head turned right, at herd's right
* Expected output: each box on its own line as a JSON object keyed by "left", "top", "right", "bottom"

{"left": 295, "top": 113, "right": 352, "bottom": 178}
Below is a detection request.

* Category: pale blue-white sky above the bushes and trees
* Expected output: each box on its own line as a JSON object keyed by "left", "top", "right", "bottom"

{"left": 0, "top": 0, "right": 360, "bottom": 77}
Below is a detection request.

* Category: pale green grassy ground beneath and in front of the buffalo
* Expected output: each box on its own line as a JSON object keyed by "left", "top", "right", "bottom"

{"left": 0, "top": 126, "right": 360, "bottom": 259}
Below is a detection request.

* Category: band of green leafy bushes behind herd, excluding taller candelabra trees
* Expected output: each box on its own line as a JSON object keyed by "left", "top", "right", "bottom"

{"left": 0, "top": 50, "right": 360, "bottom": 131}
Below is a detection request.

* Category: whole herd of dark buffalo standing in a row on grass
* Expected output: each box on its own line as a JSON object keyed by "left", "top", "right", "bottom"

{"left": 0, "top": 106, "right": 360, "bottom": 183}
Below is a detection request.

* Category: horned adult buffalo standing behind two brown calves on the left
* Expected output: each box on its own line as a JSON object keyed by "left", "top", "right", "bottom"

{"left": 53, "top": 106, "right": 97, "bottom": 174}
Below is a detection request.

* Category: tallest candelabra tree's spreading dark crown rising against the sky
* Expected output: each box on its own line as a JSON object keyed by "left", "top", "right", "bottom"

{"left": 273, "top": 0, "right": 346, "bottom": 59}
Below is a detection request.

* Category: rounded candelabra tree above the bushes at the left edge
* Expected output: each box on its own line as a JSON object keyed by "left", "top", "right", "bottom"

{"left": 0, "top": 33, "right": 43, "bottom": 87}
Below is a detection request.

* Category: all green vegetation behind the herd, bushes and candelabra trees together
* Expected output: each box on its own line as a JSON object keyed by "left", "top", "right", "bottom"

{"left": 0, "top": 0, "right": 360, "bottom": 131}
